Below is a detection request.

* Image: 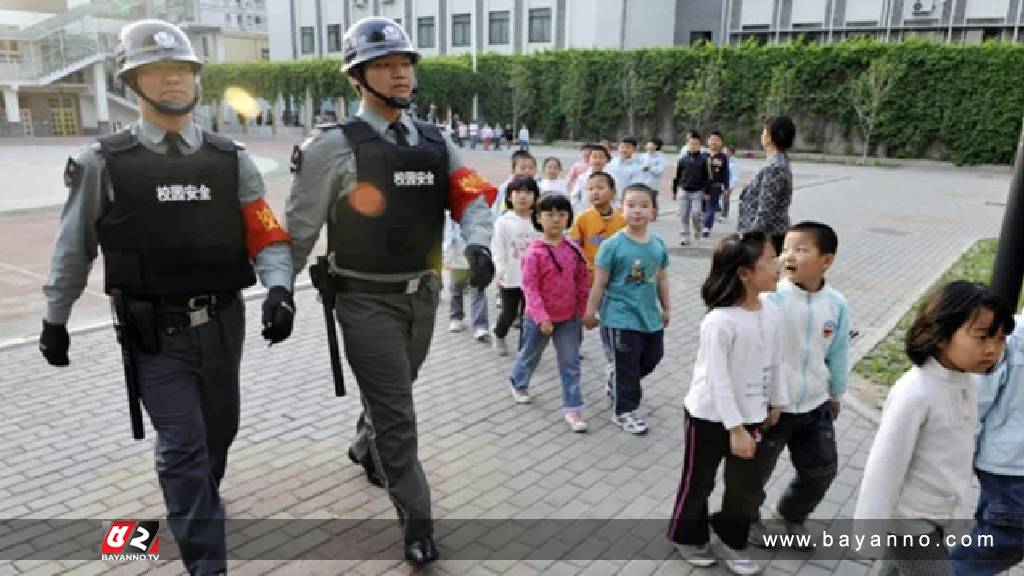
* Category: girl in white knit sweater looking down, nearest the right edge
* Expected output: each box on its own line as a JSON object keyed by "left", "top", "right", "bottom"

{"left": 853, "top": 281, "right": 1014, "bottom": 575}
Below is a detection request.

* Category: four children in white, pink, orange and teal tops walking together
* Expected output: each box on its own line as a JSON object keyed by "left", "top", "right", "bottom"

{"left": 492, "top": 163, "right": 671, "bottom": 434}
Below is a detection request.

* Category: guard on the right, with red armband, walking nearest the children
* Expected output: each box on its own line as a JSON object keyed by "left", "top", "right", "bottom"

{"left": 286, "top": 17, "right": 497, "bottom": 564}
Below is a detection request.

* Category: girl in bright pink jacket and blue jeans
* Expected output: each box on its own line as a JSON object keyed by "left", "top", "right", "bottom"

{"left": 509, "top": 194, "right": 589, "bottom": 433}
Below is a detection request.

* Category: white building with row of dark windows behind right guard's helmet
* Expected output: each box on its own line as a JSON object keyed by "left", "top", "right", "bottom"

{"left": 268, "top": 0, "right": 675, "bottom": 60}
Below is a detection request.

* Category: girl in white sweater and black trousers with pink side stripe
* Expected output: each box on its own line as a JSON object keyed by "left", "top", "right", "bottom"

{"left": 669, "top": 232, "right": 788, "bottom": 574}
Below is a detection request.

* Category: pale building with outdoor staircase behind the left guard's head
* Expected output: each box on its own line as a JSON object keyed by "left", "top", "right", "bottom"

{"left": 0, "top": 0, "right": 269, "bottom": 136}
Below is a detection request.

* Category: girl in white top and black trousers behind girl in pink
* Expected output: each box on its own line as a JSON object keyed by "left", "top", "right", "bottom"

{"left": 490, "top": 176, "right": 540, "bottom": 356}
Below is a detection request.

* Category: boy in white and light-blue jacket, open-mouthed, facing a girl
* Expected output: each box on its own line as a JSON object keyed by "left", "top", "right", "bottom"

{"left": 751, "top": 221, "right": 850, "bottom": 548}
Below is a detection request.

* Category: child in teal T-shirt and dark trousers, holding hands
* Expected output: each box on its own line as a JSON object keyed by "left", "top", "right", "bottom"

{"left": 584, "top": 183, "right": 671, "bottom": 434}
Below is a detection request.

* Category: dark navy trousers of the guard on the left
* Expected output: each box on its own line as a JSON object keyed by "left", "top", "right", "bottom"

{"left": 136, "top": 298, "right": 245, "bottom": 575}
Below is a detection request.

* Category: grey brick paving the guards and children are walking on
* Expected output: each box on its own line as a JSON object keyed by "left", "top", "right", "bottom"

{"left": 0, "top": 140, "right": 1009, "bottom": 575}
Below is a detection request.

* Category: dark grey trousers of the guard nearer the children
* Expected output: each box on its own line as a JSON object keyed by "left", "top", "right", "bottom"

{"left": 336, "top": 275, "right": 440, "bottom": 542}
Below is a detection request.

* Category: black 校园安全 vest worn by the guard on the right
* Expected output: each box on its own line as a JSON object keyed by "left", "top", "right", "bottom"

{"left": 328, "top": 118, "right": 449, "bottom": 274}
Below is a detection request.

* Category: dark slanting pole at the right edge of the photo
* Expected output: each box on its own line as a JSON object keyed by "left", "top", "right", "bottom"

{"left": 991, "top": 113, "right": 1024, "bottom": 310}
